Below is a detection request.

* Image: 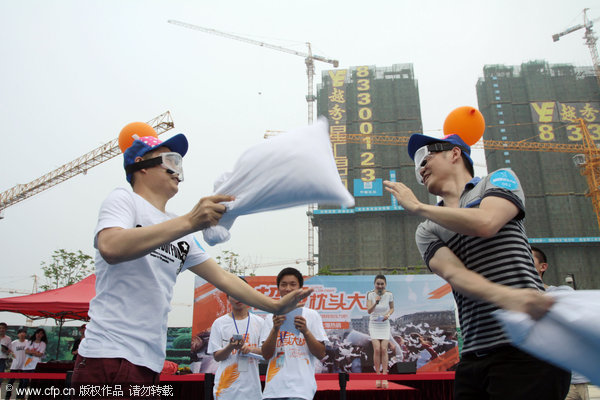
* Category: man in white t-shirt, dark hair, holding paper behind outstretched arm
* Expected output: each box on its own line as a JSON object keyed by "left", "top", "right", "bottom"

{"left": 260, "top": 268, "right": 327, "bottom": 400}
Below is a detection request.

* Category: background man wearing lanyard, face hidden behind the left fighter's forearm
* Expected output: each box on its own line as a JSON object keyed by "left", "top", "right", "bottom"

{"left": 207, "top": 278, "right": 264, "bottom": 400}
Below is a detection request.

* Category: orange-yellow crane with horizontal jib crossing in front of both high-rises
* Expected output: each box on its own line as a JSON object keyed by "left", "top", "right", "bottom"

{"left": 330, "top": 118, "right": 600, "bottom": 228}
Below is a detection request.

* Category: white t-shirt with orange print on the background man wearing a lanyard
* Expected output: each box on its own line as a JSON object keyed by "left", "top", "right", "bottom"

{"left": 207, "top": 313, "right": 264, "bottom": 400}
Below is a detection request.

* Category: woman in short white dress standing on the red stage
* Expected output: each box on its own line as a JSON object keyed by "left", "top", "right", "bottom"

{"left": 367, "top": 275, "right": 394, "bottom": 388}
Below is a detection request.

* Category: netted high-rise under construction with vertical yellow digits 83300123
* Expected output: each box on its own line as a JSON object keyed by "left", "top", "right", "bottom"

{"left": 313, "top": 64, "right": 431, "bottom": 274}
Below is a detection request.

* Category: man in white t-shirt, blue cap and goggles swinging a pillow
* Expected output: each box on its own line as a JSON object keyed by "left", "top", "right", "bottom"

{"left": 72, "top": 126, "right": 310, "bottom": 397}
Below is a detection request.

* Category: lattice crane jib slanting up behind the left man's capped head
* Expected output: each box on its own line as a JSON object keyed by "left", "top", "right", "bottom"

{"left": 0, "top": 111, "right": 174, "bottom": 219}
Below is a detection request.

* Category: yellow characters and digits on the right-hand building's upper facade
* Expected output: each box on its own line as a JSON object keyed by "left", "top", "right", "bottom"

{"left": 530, "top": 101, "right": 600, "bottom": 142}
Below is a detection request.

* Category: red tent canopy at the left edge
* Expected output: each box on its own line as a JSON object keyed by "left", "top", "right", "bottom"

{"left": 0, "top": 274, "right": 96, "bottom": 320}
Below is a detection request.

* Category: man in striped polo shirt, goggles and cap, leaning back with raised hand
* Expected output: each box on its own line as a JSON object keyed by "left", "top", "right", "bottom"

{"left": 384, "top": 134, "right": 570, "bottom": 400}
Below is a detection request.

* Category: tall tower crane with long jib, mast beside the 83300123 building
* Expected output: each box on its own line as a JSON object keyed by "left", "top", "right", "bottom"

{"left": 167, "top": 19, "right": 339, "bottom": 275}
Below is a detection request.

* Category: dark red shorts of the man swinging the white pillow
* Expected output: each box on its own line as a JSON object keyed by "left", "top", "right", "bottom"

{"left": 71, "top": 355, "right": 160, "bottom": 400}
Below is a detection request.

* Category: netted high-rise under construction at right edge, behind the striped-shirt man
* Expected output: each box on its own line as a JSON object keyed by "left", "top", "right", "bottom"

{"left": 477, "top": 61, "right": 600, "bottom": 289}
